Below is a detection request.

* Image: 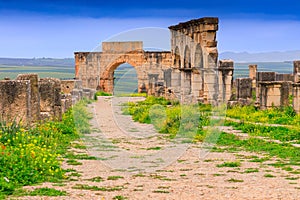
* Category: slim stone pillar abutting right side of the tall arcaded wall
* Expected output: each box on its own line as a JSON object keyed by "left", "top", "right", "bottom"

{"left": 219, "top": 60, "right": 234, "bottom": 102}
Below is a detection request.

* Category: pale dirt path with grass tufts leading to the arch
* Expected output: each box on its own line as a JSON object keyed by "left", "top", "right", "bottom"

{"left": 22, "top": 97, "right": 300, "bottom": 200}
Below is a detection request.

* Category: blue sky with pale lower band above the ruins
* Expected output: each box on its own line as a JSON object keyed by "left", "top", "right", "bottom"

{"left": 0, "top": 0, "right": 300, "bottom": 58}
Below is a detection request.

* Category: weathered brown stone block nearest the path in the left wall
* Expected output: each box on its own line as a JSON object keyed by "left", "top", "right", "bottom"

{"left": 39, "top": 78, "right": 62, "bottom": 120}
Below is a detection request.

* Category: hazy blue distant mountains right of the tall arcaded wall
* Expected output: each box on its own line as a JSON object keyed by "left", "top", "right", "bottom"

{"left": 219, "top": 50, "right": 300, "bottom": 62}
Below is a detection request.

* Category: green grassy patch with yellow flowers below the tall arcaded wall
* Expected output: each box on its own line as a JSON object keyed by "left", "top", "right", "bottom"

{"left": 123, "top": 96, "right": 212, "bottom": 138}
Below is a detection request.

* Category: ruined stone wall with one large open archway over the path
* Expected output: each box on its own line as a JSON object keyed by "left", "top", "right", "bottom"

{"left": 75, "top": 42, "right": 171, "bottom": 93}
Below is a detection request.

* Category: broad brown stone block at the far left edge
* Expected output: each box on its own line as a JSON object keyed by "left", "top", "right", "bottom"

{"left": 0, "top": 80, "right": 31, "bottom": 125}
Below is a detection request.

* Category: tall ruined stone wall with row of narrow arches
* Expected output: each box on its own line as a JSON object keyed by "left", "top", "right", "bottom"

{"left": 169, "top": 18, "right": 219, "bottom": 103}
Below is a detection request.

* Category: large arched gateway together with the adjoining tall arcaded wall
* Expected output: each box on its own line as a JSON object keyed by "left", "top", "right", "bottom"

{"left": 75, "top": 18, "right": 220, "bottom": 103}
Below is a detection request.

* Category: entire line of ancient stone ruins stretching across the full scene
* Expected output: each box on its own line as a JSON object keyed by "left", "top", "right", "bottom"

{"left": 0, "top": 18, "right": 300, "bottom": 124}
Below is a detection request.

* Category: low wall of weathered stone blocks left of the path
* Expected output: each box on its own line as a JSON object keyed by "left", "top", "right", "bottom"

{"left": 0, "top": 74, "right": 96, "bottom": 125}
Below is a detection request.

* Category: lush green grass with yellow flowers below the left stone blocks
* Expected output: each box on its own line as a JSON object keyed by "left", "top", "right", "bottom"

{"left": 0, "top": 99, "right": 90, "bottom": 196}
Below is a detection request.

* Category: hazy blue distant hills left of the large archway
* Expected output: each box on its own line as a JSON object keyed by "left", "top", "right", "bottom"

{"left": 0, "top": 58, "right": 74, "bottom": 67}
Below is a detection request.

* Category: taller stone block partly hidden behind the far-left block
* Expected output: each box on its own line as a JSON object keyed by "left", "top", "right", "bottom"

{"left": 16, "top": 74, "right": 41, "bottom": 122}
